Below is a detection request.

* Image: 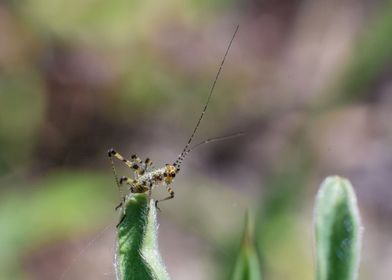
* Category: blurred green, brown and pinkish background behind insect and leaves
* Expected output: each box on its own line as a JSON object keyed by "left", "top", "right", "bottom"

{"left": 0, "top": 0, "right": 392, "bottom": 280}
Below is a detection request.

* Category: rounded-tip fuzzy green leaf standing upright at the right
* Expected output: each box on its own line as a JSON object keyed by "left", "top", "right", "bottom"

{"left": 315, "top": 176, "right": 362, "bottom": 280}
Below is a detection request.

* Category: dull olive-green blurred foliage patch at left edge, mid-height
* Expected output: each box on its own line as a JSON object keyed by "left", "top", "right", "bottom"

{"left": 0, "top": 71, "right": 45, "bottom": 175}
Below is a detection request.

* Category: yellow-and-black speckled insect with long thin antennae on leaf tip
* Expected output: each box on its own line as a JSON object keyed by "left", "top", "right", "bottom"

{"left": 108, "top": 26, "right": 242, "bottom": 227}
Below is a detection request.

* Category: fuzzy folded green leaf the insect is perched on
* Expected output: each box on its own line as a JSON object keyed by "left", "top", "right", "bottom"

{"left": 116, "top": 194, "right": 170, "bottom": 280}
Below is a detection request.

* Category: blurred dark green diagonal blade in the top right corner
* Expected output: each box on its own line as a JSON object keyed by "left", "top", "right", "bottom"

{"left": 329, "top": 0, "right": 392, "bottom": 105}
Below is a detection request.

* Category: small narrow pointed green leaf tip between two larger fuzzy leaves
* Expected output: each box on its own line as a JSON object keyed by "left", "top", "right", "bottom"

{"left": 232, "top": 212, "right": 261, "bottom": 280}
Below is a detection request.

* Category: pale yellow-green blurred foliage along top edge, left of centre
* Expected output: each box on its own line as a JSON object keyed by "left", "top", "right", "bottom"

{"left": 14, "top": 0, "right": 228, "bottom": 44}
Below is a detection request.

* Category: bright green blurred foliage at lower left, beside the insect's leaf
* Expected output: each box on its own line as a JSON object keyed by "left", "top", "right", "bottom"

{"left": 0, "top": 171, "right": 116, "bottom": 279}
